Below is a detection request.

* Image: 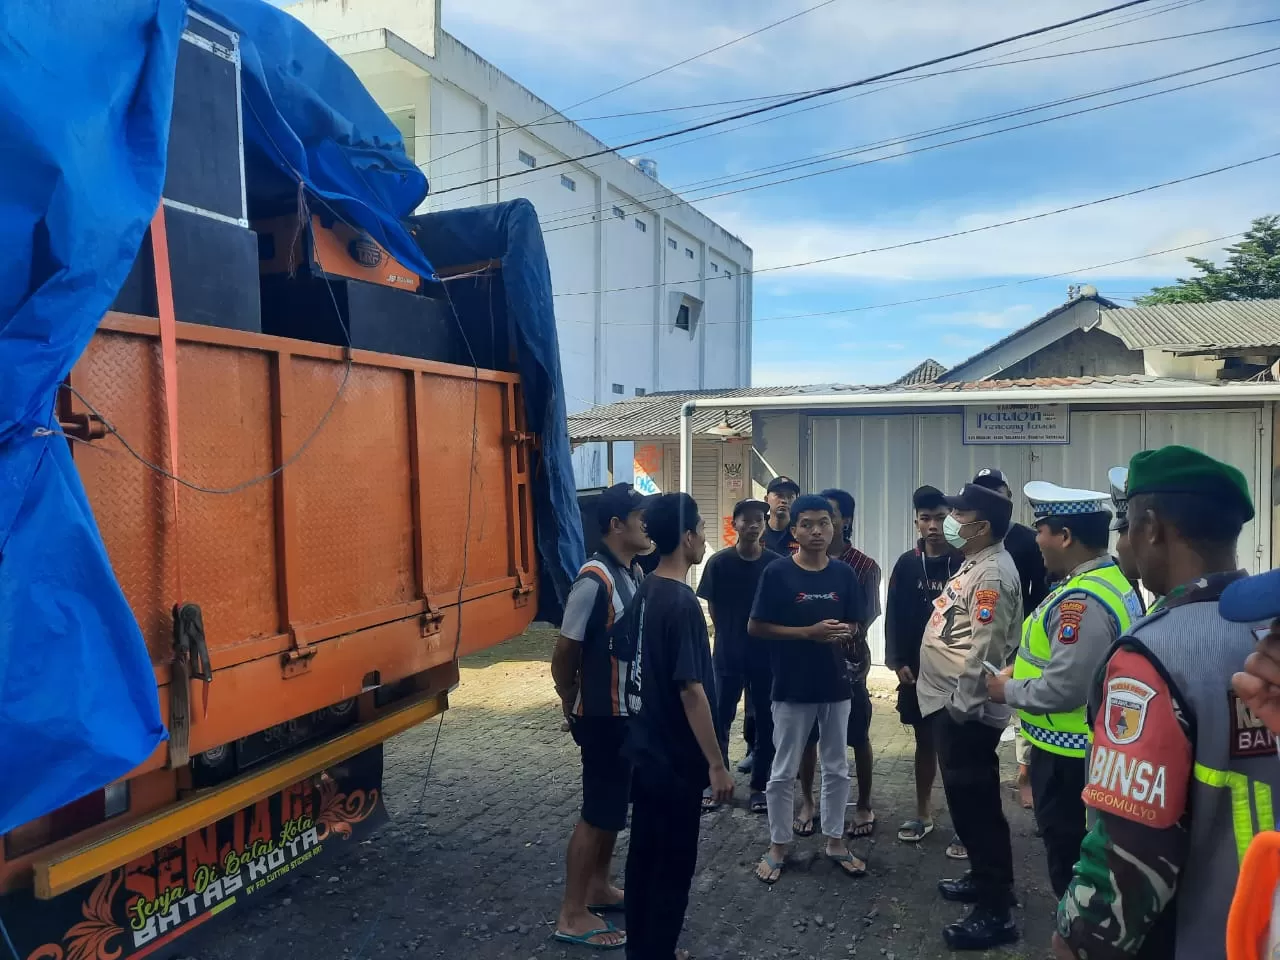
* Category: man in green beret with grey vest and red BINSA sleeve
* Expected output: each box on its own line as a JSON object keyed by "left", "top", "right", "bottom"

{"left": 1053, "top": 447, "right": 1280, "bottom": 960}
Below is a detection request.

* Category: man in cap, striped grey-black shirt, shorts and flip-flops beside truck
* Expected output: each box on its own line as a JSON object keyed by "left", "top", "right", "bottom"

{"left": 552, "top": 484, "right": 650, "bottom": 948}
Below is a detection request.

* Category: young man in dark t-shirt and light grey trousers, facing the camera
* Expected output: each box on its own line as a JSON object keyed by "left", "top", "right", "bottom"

{"left": 748, "top": 495, "right": 867, "bottom": 883}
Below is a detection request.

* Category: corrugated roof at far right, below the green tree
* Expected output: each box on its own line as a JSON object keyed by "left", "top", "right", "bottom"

{"left": 1102, "top": 300, "right": 1280, "bottom": 352}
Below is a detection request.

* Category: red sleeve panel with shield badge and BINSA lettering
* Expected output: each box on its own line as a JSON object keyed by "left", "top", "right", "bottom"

{"left": 1083, "top": 650, "right": 1192, "bottom": 829}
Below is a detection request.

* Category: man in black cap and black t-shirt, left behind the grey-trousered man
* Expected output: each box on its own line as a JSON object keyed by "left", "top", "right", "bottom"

{"left": 698, "top": 499, "right": 778, "bottom": 813}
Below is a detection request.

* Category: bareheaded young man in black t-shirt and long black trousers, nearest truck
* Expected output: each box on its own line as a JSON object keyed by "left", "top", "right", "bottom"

{"left": 625, "top": 493, "right": 733, "bottom": 960}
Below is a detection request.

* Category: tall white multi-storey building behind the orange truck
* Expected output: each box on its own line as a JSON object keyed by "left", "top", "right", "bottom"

{"left": 287, "top": 0, "right": 751, "bottom": 486}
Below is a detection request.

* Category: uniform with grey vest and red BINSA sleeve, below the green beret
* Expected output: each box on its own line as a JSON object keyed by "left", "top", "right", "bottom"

{"left": 1057, "top": 572, "right": 1280, "bottom": 960}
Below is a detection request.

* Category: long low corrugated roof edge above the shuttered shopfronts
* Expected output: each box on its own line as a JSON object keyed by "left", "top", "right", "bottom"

{"left": 568, "top": 374, "right": 1233, "bottom": 443}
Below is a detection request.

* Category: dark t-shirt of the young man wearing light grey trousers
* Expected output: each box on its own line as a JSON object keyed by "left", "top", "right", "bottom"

{"left": 751, "top": 558, "right": 867, "bottom": 703}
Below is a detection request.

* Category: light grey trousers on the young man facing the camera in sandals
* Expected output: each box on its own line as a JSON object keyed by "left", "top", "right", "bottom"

{"left": 764, "top": 700, "right": 850, "bottom": 844}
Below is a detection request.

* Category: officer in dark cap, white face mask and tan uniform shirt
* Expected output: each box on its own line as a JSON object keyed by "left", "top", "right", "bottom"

{"left": 916, "top": 484, "right": 1023, "bottom": 950}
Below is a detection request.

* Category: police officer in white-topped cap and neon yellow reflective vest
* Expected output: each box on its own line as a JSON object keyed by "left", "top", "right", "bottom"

{"left": 987, "top": 480, "right": 1139, "bottom": 897}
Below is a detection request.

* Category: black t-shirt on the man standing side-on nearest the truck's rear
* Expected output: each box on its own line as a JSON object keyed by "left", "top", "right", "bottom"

{"left": 627, "top": 576, "right": 716, "bottom": 790}
